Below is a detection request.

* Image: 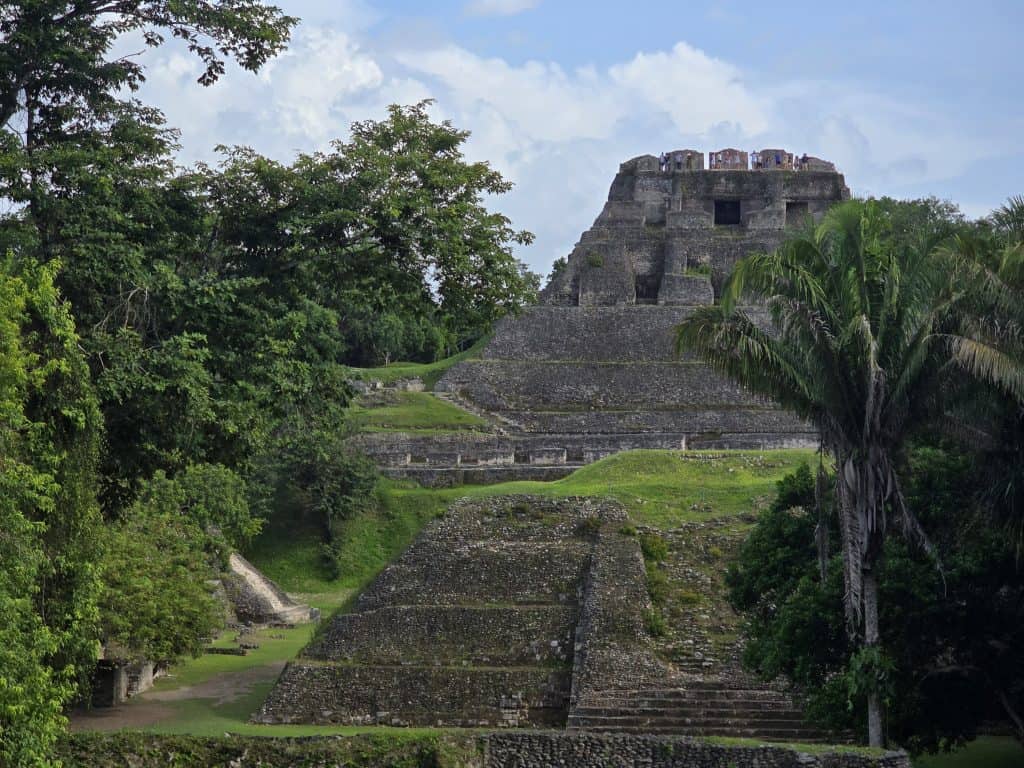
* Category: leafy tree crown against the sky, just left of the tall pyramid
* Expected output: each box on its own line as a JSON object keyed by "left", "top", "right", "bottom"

{"left": 199, "top": 102, "right": 538, "bottom": 366}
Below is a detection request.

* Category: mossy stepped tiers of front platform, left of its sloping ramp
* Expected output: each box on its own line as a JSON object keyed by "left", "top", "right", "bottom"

{"left": 254, "top": 497, "right": 622, "bottom": 727}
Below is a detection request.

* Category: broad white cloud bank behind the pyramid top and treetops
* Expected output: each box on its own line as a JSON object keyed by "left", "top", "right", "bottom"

{"left": 125, "top": 23, "right": 1009, "bottom": 272}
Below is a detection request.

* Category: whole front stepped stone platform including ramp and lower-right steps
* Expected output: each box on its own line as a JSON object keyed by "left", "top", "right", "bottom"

{"left": 255, "top": 497, "right": 823, "bottom": 741}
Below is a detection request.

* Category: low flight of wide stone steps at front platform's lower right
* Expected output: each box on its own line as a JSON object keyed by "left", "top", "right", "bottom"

{"left": 568, "top": 681, "right": 834, "bottom": 742}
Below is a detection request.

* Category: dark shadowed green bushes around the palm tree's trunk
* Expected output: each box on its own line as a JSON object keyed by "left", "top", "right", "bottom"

{"left": 727, "top": 445, "right": 1024, "bottom": 751}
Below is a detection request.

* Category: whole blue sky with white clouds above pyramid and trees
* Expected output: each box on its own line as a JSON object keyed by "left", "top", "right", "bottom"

{"left": 128, "top": 0, "right": 1024, "bottom": 273}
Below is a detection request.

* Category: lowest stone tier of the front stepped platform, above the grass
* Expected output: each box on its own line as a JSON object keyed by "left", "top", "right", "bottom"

{"left": 253, "top": 660, "right": 571, "bottom": 727}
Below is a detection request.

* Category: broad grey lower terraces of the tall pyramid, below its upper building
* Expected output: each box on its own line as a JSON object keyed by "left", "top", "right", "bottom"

{"left": 355, "top": 305, "right": 816, "bottom": 486}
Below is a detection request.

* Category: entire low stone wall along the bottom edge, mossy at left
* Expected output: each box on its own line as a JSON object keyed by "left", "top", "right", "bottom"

{"left": 54, "top": 731, "right": 910, "bottom": 768}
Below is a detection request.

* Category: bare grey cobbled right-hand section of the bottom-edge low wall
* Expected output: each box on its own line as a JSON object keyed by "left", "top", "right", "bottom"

{"left": 483, "top": 733, "right": 910, "bottom": 768}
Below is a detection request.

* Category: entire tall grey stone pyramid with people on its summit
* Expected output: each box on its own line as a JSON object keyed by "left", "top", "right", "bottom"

{"left": 360, "top": 150, "right": 849, "bottom": 485}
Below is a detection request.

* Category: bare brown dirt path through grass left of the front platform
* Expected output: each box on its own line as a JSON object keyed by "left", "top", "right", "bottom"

{"left": 71, "top": 662, "right": 285, "bottom": 731}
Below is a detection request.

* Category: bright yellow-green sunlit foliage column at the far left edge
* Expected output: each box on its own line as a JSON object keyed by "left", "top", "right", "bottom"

{"left": 0, "top": 255, "right": 99, "bottom": 766}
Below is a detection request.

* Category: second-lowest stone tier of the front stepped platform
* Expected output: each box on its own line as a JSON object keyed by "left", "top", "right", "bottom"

{"left": 302, "top": 605, "right": 577, "bottom": 666}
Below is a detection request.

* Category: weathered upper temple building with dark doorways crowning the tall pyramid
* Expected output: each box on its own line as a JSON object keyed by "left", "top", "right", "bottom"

{"left": 544, "top": 156, "right": 850, "bottom": 306}
